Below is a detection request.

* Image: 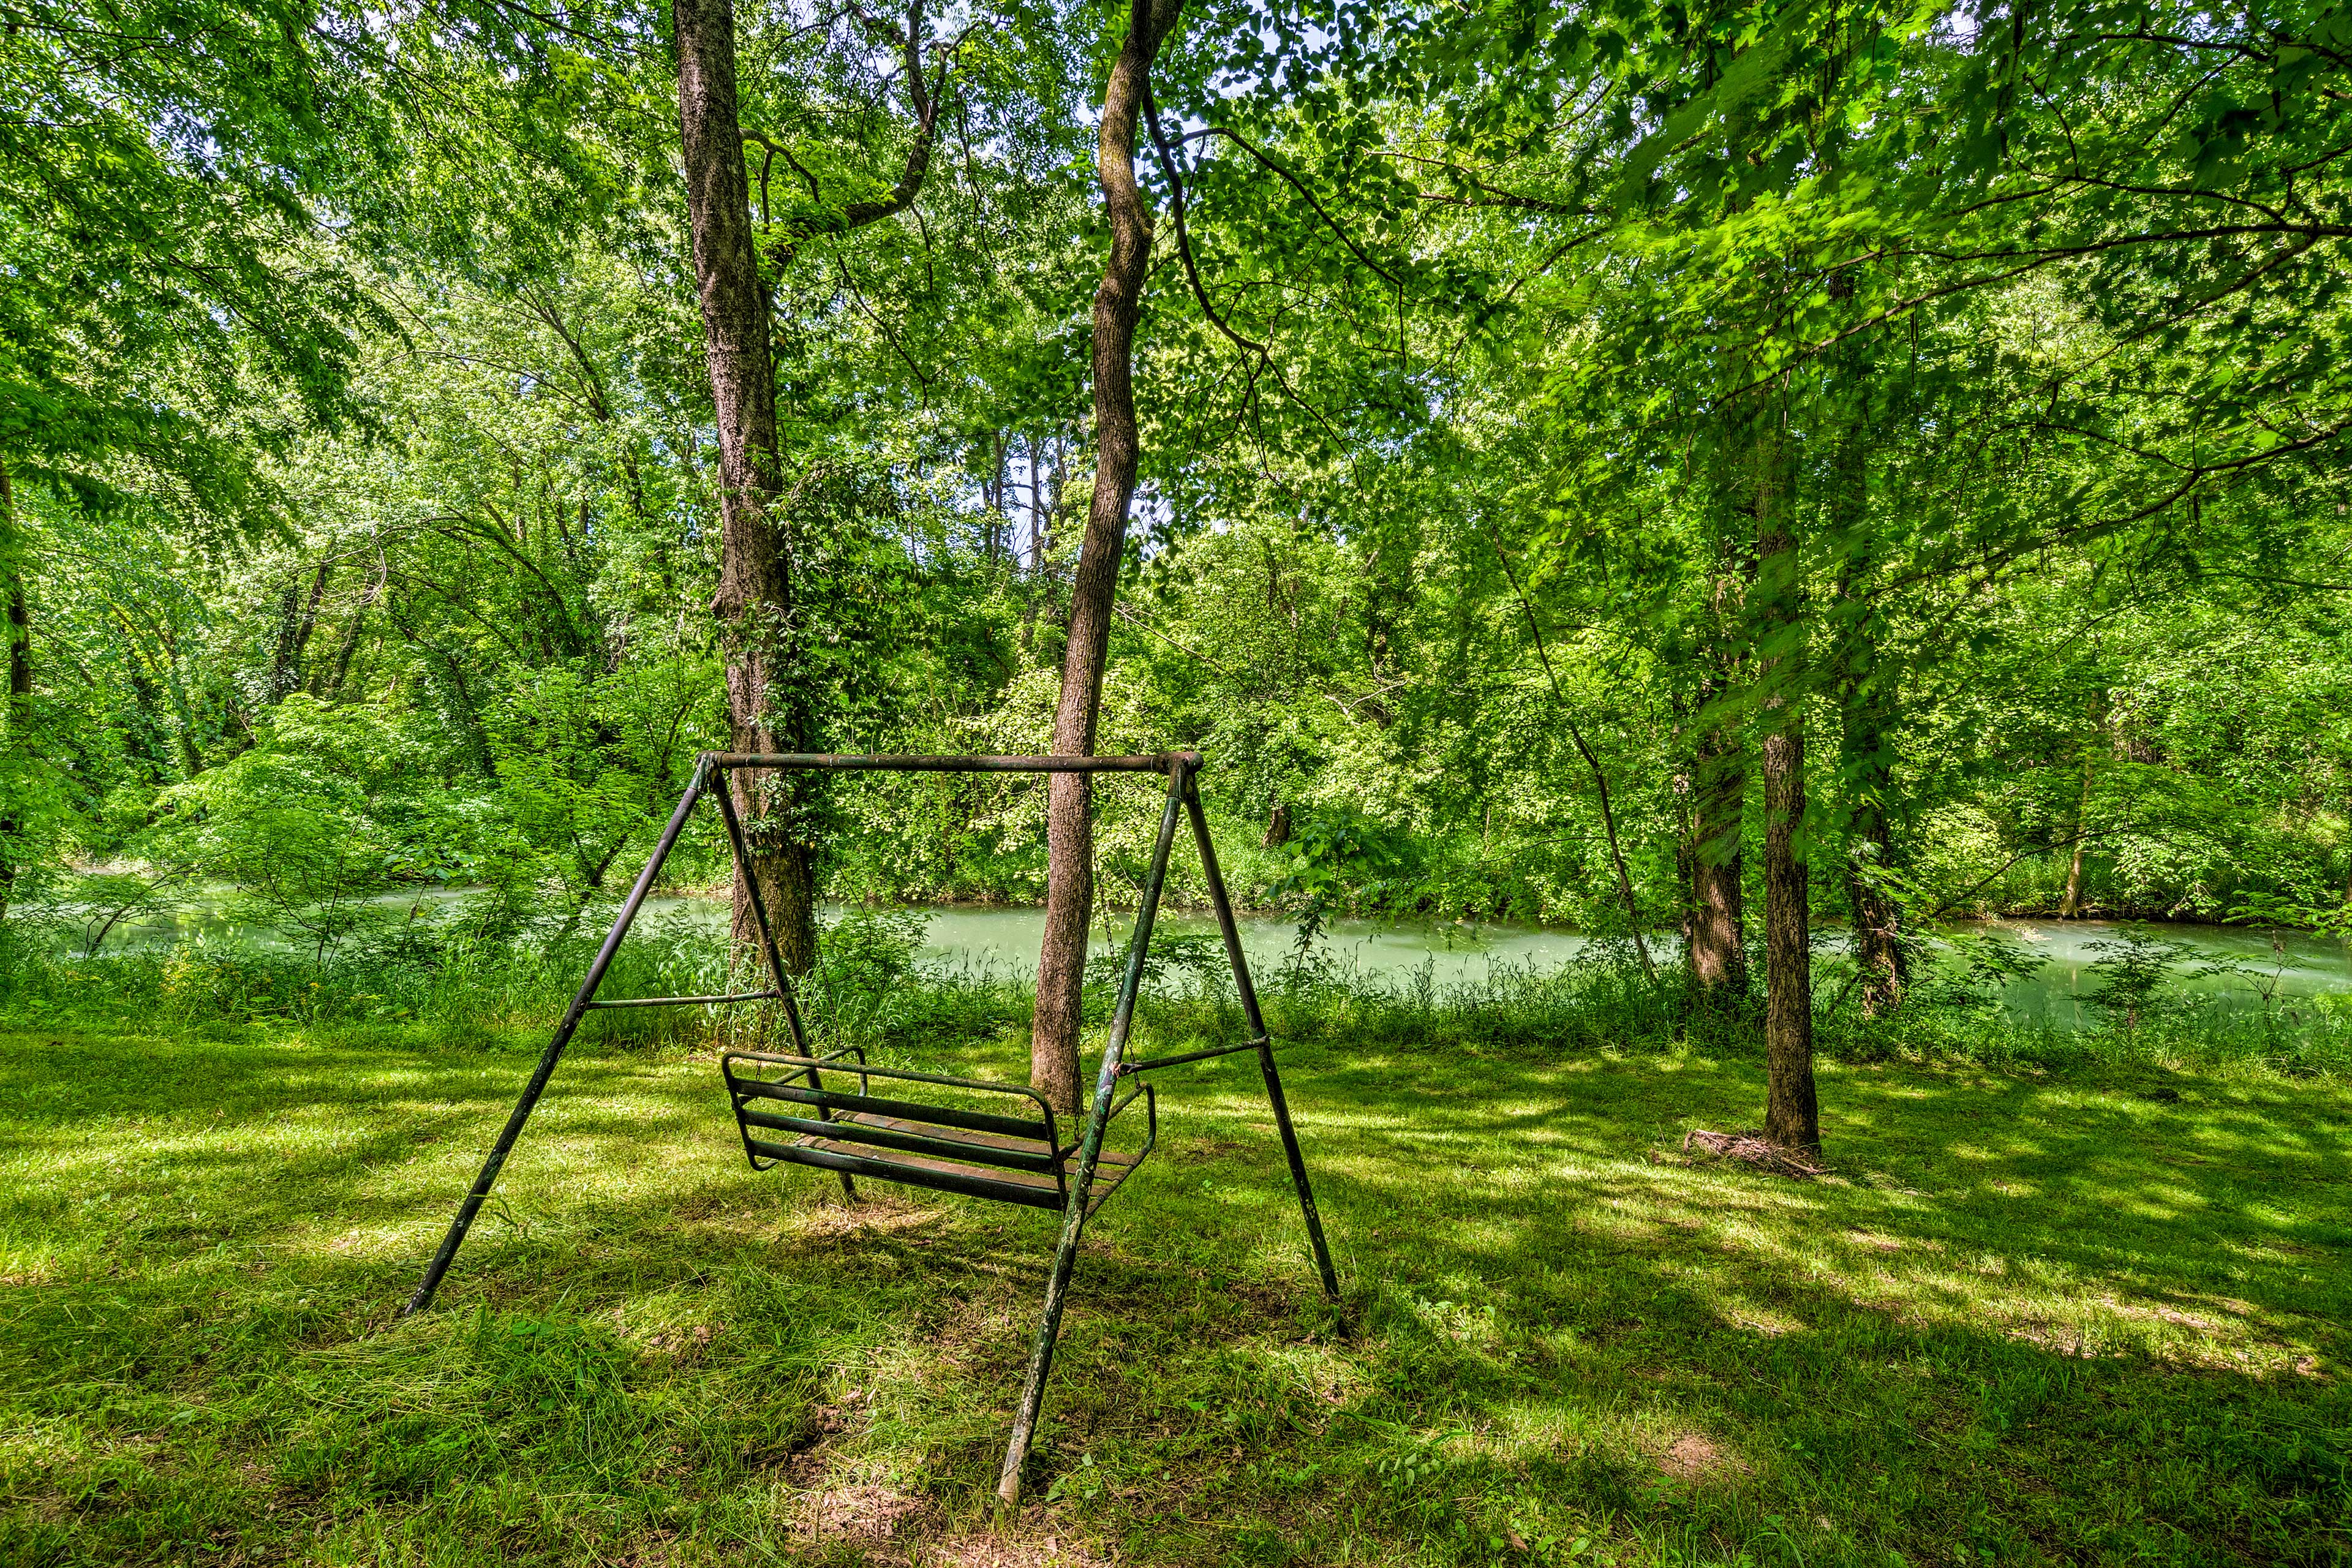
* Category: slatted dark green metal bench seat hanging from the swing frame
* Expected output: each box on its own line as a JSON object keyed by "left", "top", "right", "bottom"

{"left": 720, "top": 1046, "right": 1159, "bottom": 1218}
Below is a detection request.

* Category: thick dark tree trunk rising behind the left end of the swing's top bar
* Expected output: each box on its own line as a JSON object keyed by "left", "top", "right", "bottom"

{"left": 673, "top": 0, "right": 816, "bottom": 973}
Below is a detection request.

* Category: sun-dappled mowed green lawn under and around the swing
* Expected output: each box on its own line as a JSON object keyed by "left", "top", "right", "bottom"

{"left": 0, "top": 1011, "right": 2352, "bottom": 1566}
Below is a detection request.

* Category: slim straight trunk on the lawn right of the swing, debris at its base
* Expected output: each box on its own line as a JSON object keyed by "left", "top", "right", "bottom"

{"left": 1755, "top": 407, "right": 1820, "bottom": 1150}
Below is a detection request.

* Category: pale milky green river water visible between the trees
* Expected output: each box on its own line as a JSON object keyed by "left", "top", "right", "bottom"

{"left": 91, "top": 889, "right": 2352, "bottom": 1027}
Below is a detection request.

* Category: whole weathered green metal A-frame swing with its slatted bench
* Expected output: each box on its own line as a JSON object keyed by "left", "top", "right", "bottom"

{"left": 402, "top": 752, "right": 1338, "bottom": 1504}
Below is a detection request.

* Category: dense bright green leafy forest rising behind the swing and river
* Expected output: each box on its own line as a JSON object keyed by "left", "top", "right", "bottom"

{"left": 0, "top": 0, "right": 2352, "bottom": 1090}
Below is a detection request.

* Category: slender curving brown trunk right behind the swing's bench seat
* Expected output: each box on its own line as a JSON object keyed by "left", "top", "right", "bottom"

{"left": 1030, "top": 0, "right": 1183, "bottom": 1110}
